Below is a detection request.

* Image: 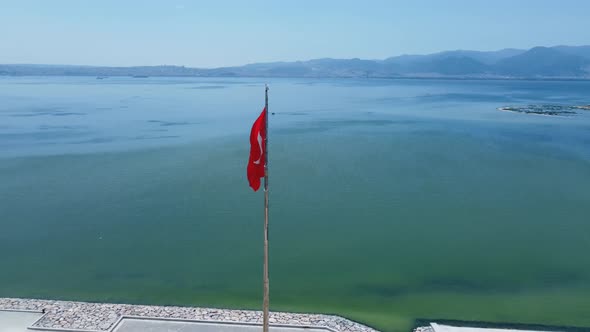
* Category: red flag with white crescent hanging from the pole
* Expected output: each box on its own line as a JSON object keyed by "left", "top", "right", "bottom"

{"left": 248, "top": 107, "right": 266, "bottom": 191}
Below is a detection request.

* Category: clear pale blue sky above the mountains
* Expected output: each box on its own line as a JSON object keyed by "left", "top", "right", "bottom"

{"left": 0, "top": 0, "right": 590, "bottom": 68}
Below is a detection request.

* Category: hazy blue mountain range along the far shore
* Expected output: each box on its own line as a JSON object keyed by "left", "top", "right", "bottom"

{"left": 0, "top": 46, "right": 590, "bottom": 79}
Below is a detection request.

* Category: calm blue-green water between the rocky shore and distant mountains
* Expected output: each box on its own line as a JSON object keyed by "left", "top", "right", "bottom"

{"left": 0, "top": 77, "right": 590, "bottom": 331}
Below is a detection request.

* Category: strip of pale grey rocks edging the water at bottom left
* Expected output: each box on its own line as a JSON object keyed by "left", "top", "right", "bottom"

{"left": 0, "top": 298, "right": 377, "bottom": 332}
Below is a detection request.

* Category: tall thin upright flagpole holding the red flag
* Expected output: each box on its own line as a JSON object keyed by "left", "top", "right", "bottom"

{"left": 262, "top": 84, "right": 270, "bottom": 332}
